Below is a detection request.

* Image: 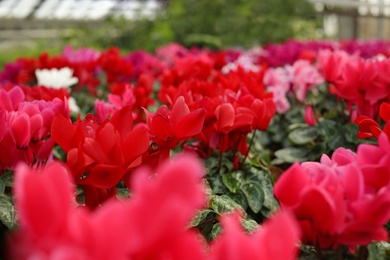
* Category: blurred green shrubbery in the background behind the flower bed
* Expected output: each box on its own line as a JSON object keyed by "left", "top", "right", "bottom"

{"left": 64, "top": 0, "right": 320, "bottom": 51}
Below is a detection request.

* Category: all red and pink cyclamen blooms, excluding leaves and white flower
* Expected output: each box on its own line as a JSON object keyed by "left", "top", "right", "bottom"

{"left": 0, "top": 40, "right": 390, "bottom": 259}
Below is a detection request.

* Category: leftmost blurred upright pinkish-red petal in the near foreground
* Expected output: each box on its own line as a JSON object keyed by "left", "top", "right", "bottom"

{"left": 15, "top": 163, "right": 73, "bottom": 239}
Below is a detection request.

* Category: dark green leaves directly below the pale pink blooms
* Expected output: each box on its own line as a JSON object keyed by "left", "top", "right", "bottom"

{"left": 256, "top": 85, "right": 376, "bottom": 171}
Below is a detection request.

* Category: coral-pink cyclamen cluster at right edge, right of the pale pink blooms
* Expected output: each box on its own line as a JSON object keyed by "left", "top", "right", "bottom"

{"left": 319, "top": 51, "right": 390, "bottom": 121}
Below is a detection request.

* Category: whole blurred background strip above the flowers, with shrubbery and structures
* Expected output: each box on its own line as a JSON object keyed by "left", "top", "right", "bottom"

{"left": 0, "top": 0, "right": 390, "bottom": 69}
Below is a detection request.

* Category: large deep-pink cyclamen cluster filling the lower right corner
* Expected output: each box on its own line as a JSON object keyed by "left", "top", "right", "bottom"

{"left": 274, "top": 135, "right": 390, "bottom": 248}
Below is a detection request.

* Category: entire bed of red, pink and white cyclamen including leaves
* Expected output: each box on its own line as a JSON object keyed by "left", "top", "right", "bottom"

{"left": 0, "top": 41, "right": 390, "bottom": 259}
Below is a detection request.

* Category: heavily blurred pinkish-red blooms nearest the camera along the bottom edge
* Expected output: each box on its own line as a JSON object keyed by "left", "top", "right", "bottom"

{"left": 8, "top": 155, "right": 299, "bottom": 260}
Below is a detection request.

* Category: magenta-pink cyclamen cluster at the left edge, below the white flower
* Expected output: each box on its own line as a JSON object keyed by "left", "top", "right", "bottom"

{"left": 0, "top": 87, "right": 69, "bottom": 170}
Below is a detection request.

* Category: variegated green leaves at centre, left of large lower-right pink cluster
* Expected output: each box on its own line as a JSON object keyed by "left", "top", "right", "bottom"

{"left": 190, "top": 153, "right": 279, "bottom": 241}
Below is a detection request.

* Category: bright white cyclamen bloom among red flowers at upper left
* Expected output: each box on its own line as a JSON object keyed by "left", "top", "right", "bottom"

{"left": 35, "top": 67, "right": 79, "bottom": 89}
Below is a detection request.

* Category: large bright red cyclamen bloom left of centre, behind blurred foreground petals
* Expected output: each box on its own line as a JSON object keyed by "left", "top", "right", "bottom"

{"left": 51, "top": 104, "right": 149, "bottom": 208}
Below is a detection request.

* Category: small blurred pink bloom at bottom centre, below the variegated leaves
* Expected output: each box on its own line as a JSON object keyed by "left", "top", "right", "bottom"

{"left": 211, "top": 211, "right": 299, "bottom": 260}
